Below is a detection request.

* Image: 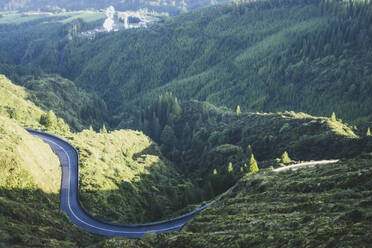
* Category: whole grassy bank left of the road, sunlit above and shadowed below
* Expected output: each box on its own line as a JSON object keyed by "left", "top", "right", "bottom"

{"left": 0, "top": 116, "right": 99, "bottom": 247}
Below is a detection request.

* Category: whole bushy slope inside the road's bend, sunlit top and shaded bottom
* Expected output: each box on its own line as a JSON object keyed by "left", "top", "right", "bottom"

{"left": 70, "top": 130, "right": 200, "bottom": 223}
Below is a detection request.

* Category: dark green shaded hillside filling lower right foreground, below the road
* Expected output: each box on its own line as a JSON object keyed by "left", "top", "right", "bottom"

{"left": 98, "top": 154, "right": 372, "bottom": 248}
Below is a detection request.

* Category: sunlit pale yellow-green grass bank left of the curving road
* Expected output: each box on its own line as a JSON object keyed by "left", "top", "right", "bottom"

{"left": 0, "top": 116, "right": 61, "bottom": 193}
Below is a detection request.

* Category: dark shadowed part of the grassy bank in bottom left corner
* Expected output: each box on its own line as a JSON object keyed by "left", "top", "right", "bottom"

{"left": 0, "top": 187, "right": 103, "bottom": 247}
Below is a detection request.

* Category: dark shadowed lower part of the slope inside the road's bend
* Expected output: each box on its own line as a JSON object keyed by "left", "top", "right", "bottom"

{"left": 80, "top": 143, "right": 203, "bottom": 224}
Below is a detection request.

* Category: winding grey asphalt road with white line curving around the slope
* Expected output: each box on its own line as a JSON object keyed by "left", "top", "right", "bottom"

{"left": 26, "top": 129, "right": 211, "bottom": 238}
